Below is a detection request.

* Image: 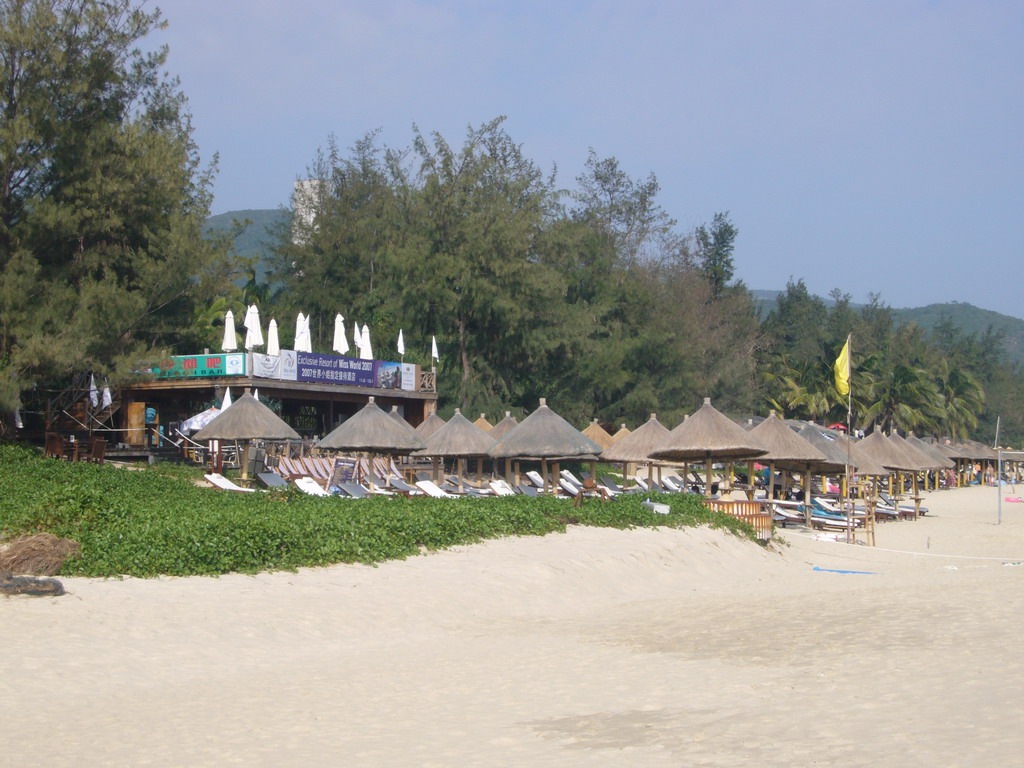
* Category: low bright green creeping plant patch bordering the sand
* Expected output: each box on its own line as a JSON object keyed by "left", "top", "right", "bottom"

{"left": 0, "top": 444, "right": 754, "bottom": 577}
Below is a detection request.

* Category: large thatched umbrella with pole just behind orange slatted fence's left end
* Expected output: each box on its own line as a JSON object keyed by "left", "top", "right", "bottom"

{"left": 650, "top": 397, "right": 767, "bottom": 496}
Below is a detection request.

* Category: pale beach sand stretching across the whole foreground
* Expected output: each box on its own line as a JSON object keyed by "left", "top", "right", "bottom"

{"left": 0, "top": 488, "right": 1024, "bottom": 768}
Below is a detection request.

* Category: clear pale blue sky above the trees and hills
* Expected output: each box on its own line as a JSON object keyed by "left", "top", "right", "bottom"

{"left": 155, "top": 0, "right": 1024, "bottom": 317}
